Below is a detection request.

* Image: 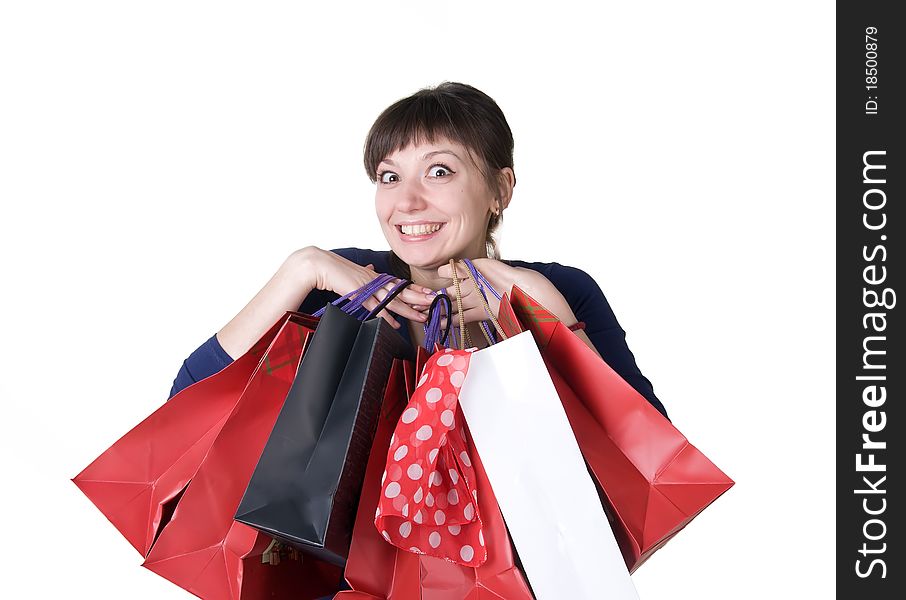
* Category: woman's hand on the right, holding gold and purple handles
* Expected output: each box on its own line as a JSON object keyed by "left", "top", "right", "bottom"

{"left": 437, "top": 258, "right": 576, "bottom": 326}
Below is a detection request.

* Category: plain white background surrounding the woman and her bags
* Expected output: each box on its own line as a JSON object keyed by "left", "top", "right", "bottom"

{"left": 0, "top": 0, "right": 835, "bottom": 600}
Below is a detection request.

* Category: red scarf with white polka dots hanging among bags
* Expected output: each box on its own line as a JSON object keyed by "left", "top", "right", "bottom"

{"left": 374, "top": 349, "right": 487, "bottom": 567}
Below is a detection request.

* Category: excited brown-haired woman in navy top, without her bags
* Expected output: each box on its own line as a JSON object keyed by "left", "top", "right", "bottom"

{"left": 170, "top": 82, "right": 666, "bottom": 416}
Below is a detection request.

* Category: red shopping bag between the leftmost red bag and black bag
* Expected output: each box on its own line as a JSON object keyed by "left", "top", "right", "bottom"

{"left": 143, "top": 316, "right": 342, "bottom": 600}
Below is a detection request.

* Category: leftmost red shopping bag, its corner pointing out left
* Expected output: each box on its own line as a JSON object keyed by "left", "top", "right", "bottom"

{"left": 73, "top": 313, "right": 317, "bottom": 556}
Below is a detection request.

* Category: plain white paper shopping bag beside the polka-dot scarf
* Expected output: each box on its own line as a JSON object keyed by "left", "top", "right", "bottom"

{"left": 459, "top": 332, "right": 638, "bottom": 600}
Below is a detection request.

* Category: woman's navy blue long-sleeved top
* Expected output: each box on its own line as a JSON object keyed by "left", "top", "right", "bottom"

{"left": 170, "top": 248, "right": 667, "bottom": 417}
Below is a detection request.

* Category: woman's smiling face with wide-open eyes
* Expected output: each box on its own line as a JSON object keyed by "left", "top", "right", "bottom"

{"left": 375, "top": 138, "right": 495, "bottom": 269}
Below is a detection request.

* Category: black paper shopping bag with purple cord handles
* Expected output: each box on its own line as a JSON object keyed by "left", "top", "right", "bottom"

{"left": 235, "top": 300, "right": 412, "bottom": 566}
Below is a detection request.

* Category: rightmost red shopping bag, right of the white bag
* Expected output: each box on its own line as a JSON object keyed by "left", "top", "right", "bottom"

{"left": 499, "top": 286, "right": 734, "bottom": 572}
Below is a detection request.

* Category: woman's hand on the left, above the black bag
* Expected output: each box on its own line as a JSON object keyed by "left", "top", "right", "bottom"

{"left": 294, "top": 246, "right": 431, "bottom": 329}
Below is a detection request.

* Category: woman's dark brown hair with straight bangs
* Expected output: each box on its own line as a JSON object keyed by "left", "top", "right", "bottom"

{"left": 365, "top": 81, "right": 513, "bottom": 272}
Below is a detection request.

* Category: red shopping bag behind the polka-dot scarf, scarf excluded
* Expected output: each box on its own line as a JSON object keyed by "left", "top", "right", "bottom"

{"left": 336, "top": 356, "right": 532, "bottom": 600}
